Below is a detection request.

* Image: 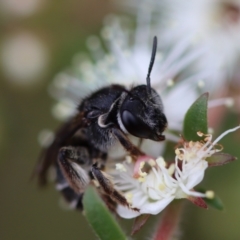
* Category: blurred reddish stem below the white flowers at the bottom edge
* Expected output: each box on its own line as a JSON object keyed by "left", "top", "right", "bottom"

{"left": 153, "top": 200, "right": 182, "bottom": 240}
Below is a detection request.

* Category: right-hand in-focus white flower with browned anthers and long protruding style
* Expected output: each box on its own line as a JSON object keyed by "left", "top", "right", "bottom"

{"left": 174, "top": 126, "right": 240, "bottom": 198}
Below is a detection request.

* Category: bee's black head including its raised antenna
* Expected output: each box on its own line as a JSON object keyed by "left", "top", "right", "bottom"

{"left": 119, "top": 37, "right": 167, "bottom": 141}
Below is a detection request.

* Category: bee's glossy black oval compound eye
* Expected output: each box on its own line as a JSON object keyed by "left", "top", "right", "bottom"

{"left": 122, "top": 110, "right": 151, "bottom": 138}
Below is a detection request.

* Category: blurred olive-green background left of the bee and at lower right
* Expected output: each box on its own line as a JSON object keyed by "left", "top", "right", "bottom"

{"left": 0, "top": 0, "right": 240, "bottom": 240}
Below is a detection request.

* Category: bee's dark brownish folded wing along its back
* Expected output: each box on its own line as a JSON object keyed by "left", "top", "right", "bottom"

{"left": 33, "top": 113, "right": 86, "bottom": 186}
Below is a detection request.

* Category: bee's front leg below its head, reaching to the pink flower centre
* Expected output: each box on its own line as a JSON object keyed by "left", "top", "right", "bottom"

{"left": 112, "top": 128, "right": 143, "bottom": 157}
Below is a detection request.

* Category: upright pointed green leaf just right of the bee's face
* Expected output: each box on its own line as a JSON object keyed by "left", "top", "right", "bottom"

{"left": 183, "top": 93, "right": 209, "bottom": 141}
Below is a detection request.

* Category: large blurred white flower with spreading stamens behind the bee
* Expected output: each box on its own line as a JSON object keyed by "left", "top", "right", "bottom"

{"left": 50, "top": 15, "right": 207, "bottom": 135}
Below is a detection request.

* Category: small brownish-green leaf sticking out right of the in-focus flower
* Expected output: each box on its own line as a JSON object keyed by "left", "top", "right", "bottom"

{"left": 206, "top": 152, "right": 237, "bottom": 167}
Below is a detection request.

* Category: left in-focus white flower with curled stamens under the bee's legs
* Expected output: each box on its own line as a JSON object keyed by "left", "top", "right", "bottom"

{"left": 114, "top": 158, "right": 177, "bottom": 218}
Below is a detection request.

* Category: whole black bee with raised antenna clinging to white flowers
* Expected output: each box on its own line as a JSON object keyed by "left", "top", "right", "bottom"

{"left": 37, "top": 37, "right": 167, "bottom": 209}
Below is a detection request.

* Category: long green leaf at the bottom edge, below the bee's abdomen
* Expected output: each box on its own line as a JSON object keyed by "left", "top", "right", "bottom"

{"left": 83, "top": 186, "right": 127, "bottom": 240}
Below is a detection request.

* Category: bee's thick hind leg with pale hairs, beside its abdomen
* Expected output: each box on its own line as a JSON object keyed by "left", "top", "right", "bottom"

{"left": 58, "top": 147, "right": 90, "bottom": 194}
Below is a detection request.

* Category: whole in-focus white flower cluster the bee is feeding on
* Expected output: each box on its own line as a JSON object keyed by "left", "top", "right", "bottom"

{"left": 113, "top": 126, "right": 240, "bottom": 218}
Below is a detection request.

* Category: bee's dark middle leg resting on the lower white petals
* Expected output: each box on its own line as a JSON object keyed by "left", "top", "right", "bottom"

{"left": 92, "top": 163, "right": 138, "bottom": 211}
